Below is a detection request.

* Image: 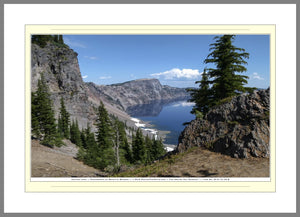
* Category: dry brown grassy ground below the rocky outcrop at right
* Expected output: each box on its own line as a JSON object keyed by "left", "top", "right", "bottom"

{"left": 116, "top": 148, "right": 269, "bottom": 177}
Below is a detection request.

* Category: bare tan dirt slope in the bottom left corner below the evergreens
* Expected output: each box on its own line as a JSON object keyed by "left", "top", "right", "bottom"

{"left": 31, "top": 140, "right": 101, "bottom": 177}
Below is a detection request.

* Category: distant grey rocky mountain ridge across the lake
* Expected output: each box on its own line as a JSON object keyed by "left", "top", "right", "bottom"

{"left": 88, "top": 79, "right": 189, "bottom": 111}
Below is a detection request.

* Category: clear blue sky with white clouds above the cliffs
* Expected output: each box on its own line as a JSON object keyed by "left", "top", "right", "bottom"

{"left": 64, "top": 35, "right": 270, "bottom": 88}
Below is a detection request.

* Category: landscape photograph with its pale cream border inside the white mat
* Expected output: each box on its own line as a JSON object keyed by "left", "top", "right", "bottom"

{"left": 25, "top": 25, "right": 276, "bottom": 193}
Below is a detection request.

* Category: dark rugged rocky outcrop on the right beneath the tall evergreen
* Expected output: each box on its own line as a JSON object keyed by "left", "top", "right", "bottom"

{"left": 177, "top": 89, "right": 270, "bottom": 158}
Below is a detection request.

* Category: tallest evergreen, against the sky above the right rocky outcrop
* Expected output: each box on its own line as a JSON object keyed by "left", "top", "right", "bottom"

{"left": 204, "top": 35, "right": 251, "bottom": 102}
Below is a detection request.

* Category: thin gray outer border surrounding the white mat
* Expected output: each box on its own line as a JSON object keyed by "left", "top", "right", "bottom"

{"left": 0, "top": 0, "right": 300, "bottom": 217}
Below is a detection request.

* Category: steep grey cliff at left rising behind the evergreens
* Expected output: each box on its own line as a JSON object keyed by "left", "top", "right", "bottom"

{"left": 31, "top": 43, "right": 95, "bottom": 128}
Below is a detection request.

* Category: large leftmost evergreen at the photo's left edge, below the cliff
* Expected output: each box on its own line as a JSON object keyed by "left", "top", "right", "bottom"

{"left": 31, "top": 74, "right": 63, "bottom": 147}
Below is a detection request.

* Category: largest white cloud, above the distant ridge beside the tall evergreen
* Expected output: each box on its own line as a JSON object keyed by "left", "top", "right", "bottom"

{"left": 151, "top": 68, "right": 201, "bottom": 80}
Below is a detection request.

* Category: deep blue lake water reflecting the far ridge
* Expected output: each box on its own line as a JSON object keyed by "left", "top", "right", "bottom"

{"left": 131, "top": 101, "right": 195, "bottom": 145}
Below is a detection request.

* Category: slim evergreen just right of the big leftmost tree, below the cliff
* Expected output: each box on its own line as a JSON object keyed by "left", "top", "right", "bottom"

{"left": 58, "top": 98, "right": 70, "bottom": 139}
